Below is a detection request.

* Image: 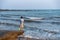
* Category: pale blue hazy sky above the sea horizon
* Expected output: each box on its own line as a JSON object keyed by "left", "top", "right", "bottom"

{"left": 0, "top": 0, "right": 60, "bottom": 9}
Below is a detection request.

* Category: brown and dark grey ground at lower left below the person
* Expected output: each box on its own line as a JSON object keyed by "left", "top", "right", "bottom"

{"left": 0, "top": 30, "right": 24, "bottom": 40}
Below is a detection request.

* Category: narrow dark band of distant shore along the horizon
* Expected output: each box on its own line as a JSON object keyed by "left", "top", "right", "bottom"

{"left": 0, "top": 9, "right": 60, "bottom": 11}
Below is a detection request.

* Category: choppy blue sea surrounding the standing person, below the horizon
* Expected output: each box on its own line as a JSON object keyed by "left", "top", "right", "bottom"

{"left": 0, "top": 10, "right": 60, "bottom": 38}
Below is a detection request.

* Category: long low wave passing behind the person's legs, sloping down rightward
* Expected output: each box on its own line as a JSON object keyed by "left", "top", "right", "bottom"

{"left": 0, "top": 22, "right": 59, "bottom": 34}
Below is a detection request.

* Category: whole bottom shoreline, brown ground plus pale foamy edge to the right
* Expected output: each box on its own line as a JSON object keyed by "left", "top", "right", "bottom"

{"left": 0, "top": 30, "right": 60, "bottom": 40}
